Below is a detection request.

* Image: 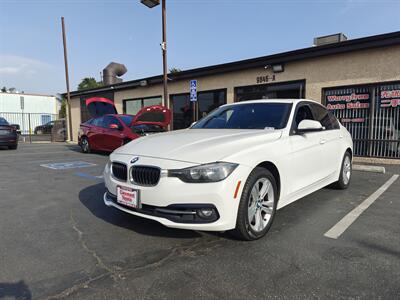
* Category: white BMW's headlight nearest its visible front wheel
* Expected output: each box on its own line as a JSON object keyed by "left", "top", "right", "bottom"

{"left": 168, "top": 162, "right": 238, "bottom": 183}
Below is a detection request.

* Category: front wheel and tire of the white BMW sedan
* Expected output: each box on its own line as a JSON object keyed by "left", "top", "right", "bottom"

{"left": 232, "top": 167, "right": 278, "bottom": 241}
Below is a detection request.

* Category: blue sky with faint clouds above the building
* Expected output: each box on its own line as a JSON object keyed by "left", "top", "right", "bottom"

{"left": 0, "top": 0, "right": 400, "bottom": 94}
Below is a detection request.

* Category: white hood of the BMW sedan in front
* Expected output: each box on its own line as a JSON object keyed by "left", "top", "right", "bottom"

{"left": 114, "top": 129, "right": 282, "bottom": 163}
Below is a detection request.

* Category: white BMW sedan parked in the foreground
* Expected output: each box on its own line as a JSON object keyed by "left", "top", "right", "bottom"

{"left": 104, "top": 100, "right": 353, "bottom": 240}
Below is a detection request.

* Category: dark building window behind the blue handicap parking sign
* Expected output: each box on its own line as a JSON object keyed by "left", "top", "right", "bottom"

{"left": 170, "top": 89, "right": 226, "bottom": 130}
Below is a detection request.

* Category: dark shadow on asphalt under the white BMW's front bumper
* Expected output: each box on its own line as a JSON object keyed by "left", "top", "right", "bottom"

{"left": 79, "top": 183, "right": 202, "bottom": 239}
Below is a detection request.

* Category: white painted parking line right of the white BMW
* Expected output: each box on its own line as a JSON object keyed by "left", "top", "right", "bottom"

{"left": 324, "top": 174, "right": 399, "bottom": 239}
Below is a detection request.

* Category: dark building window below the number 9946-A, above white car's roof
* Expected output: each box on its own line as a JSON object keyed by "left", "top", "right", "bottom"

{"left": 235, "top": 80, "right": 305, "bottom": 102}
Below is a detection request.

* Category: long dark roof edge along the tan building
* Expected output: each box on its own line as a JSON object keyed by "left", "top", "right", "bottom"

{"left": 63, "top": 31, "right": 400, "bottom": 97}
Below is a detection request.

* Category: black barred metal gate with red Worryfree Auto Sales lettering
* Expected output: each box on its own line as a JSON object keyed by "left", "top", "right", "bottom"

{"left": 324, "top": 82, "right": 400, "bottom": 158}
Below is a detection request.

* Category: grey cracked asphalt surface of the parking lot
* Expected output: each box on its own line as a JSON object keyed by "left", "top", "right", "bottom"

{"left": 0, "top": 144, "right": 400, "bottom": 299}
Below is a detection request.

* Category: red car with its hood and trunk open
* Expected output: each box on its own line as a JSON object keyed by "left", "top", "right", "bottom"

{"left": 78, "top": 97, "right": 171, "bottom": 153}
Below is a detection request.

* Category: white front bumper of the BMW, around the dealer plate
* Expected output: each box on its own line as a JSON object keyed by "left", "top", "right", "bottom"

{"left": 104, "top": 157, "right": 251, "bottom": 231}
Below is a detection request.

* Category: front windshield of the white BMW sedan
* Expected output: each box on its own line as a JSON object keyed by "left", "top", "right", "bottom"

{"left": 191, "top": 102, "right": 292, "bottom": 129}
